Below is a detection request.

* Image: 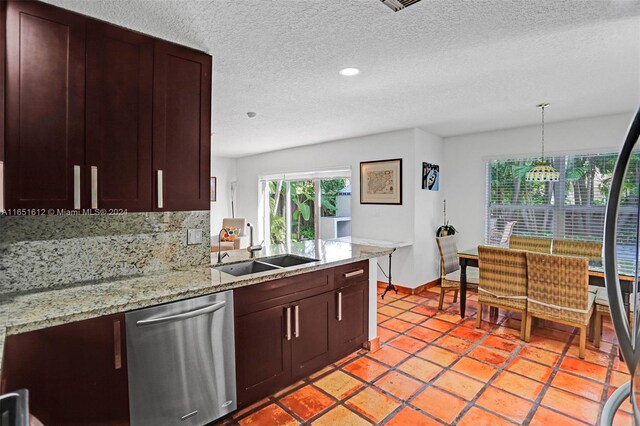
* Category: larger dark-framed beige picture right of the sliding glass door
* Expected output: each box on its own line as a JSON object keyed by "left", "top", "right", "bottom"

{"left": 360, "top": 158, "right": 402, "bottom": 205}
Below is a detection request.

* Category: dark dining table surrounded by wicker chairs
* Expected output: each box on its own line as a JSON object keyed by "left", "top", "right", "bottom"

{"left": 458, "top": 246, "right": 636, "bottom": 318}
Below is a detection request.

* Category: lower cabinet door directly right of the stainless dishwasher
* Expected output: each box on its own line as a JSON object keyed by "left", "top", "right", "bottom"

{"left": 235, "top": 306, "right": 291, "bottom": 407}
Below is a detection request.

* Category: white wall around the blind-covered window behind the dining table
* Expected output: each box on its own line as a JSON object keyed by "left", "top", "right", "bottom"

{"left": 440, "top": 113, "right": 633, "bottom": 249}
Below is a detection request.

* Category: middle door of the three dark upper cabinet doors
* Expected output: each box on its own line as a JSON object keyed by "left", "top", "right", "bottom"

{"left": 84, "top": 20, "right": 153, "bottom": 211}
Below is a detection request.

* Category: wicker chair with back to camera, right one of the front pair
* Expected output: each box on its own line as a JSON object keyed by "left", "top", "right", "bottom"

{"left": 524, "top": 252, "right": 596, "bottom": 359}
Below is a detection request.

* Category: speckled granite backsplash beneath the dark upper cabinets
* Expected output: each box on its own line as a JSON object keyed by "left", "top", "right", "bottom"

{"left": 0, "top": 211, "right": 210, "bottom": 293}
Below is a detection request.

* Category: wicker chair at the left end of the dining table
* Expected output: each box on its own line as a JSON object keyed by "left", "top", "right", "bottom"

{"left": 436, "top": 235, "right": 479, "bottom": 310}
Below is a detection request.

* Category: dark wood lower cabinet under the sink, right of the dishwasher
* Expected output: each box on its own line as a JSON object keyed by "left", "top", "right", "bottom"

{"left": 234, "top": 264, "right": 369, "bottom": 408}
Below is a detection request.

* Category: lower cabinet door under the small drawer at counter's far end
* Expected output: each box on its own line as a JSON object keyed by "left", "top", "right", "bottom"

{"left": 331, "top": 281, "right": 369, "bottom": 360}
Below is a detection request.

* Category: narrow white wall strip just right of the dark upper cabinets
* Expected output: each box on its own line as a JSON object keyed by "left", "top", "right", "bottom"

{"left": 211, "top": 155, "right": 241, "bottom": 235}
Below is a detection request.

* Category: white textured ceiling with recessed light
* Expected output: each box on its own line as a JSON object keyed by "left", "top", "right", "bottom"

{"left": 42, "top": 0, "right": 640, "bottom": 156}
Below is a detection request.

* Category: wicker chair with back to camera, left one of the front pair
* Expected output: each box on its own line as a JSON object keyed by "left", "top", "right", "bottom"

{"left": 476, "top": 246, "right": 527, "bottom": 340}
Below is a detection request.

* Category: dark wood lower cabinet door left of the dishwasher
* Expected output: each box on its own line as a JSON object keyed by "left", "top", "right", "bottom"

{"left": 2, "top": 314, "right": 129, "bottom": 425}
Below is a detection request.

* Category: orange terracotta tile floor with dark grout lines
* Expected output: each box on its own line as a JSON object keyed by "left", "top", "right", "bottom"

{"left": 222, "top": 288, "right": 632, "bottom": 426}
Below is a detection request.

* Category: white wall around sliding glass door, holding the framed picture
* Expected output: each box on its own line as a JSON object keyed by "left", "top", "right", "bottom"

{"left": 237, "top": 129, "right": 442, "bottom": 287}
